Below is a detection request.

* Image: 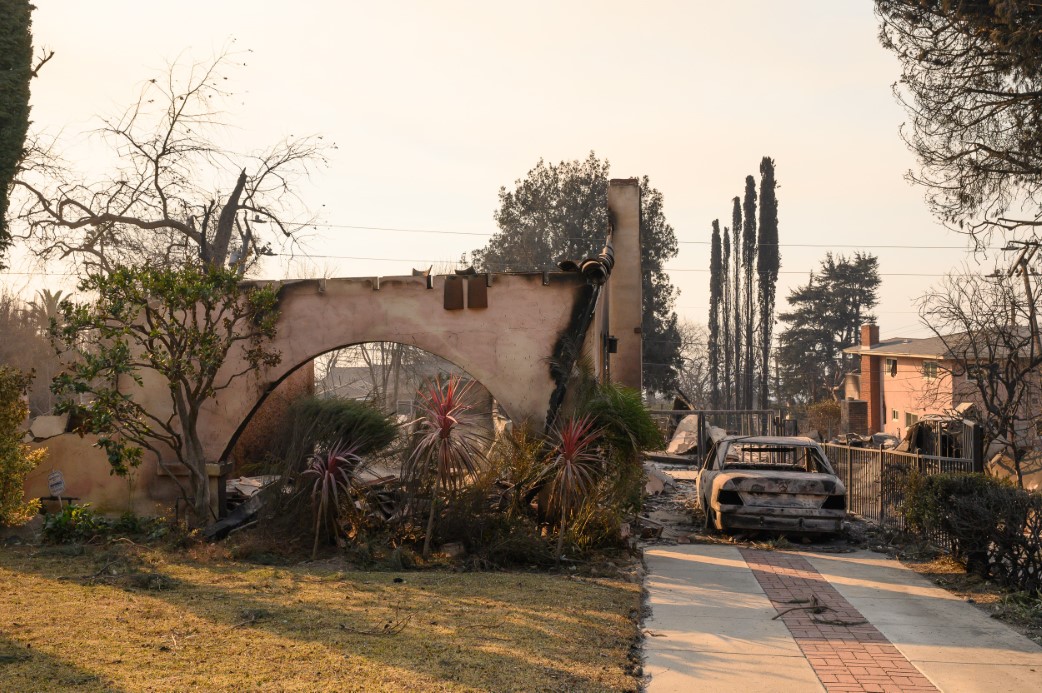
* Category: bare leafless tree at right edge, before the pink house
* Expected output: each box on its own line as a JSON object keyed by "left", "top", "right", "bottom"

{"left": 919, "top": 266, "right": 1042, "bottom": 486}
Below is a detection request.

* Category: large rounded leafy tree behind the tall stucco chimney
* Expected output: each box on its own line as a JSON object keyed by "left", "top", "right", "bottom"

{"left": 471, "top": 152, "right": 680, "bottom": 392}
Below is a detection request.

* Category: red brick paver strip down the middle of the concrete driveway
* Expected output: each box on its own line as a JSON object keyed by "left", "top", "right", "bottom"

{"left": 740, "top": 548, "right": 937, "bottom": 693}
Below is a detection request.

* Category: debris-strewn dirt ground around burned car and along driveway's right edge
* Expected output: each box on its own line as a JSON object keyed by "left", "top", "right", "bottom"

{"left": 642, "top": 466, "right": 1042, "bottom": 645}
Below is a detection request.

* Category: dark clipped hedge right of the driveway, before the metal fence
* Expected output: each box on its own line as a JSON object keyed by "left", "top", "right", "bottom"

{"left": 904, "top": 472, "right": 1042, "bottom": 592}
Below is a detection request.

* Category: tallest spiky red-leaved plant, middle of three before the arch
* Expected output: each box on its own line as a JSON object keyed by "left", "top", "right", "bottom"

{"left": 405, "top": 376, "right": 482, "bottom": 558}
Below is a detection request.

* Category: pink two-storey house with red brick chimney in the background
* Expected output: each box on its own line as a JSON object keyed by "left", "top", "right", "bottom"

{"left": 843, "top": 325, "right": 1040, "bottom": 439}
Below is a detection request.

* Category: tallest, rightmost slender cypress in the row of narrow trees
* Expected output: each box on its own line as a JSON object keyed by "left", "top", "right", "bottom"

{"left": 756, "top": 156, "right": 782, "bottom": 410}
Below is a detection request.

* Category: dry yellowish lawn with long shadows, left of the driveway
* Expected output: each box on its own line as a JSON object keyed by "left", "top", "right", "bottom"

{"left": 0, "top": 546, "right": 640, "bottom": 691}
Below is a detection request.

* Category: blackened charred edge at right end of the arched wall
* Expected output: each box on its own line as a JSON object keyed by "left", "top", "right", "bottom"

{"left": 545, "top": 237, "right": 615, "bottom": 432}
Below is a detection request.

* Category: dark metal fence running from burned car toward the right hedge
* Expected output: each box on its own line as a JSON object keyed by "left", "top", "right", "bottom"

{"left": 822, "top": 444, "right": 974, "bottom": 528}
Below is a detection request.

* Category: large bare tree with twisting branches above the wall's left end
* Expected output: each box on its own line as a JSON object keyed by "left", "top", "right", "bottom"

{"left": 14, "top": 54, "right": 324, "bottom": 272}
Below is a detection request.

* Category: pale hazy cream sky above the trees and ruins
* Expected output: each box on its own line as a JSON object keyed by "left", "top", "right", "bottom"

{"left": 0, "top": 0, "right": 1008, "bottom": 337}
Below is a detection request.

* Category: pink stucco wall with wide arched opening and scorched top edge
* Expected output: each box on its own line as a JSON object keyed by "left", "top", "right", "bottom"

{"left": 189, "top": 273, "right": 595, "bottom": 461}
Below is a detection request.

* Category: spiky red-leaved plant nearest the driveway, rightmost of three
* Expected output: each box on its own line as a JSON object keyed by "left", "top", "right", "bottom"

{"left": 547, "top": 417, "right": 603, "bottom": 561}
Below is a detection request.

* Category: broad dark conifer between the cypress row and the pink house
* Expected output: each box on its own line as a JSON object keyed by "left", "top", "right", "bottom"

{"left": 778, "top": 252, "right": 880, "bottom": 403}
